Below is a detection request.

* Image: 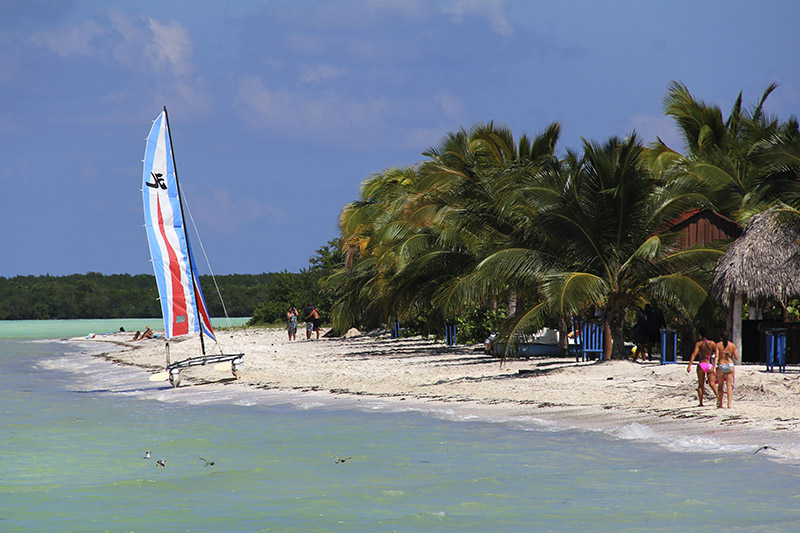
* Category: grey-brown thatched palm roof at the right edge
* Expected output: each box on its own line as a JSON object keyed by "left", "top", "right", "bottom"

{"left": 712, "top": 207, "right": 800, "bottom": 303}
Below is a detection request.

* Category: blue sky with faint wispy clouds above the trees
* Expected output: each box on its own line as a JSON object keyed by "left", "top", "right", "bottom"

{"left": 0, "top": 0, "right": 800, "bottom": 277}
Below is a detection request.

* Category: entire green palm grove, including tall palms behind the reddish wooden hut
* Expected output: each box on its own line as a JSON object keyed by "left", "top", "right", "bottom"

{"left": 324, "top": 83, "right": 800, "bottom": 358}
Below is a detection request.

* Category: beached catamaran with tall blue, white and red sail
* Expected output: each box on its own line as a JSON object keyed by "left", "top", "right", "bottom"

{"left": 142, "top": 107, "right": 244, "bottom": 387}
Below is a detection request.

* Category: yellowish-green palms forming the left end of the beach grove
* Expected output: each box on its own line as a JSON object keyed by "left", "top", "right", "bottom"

{"left": 328, "top": 123, "right": 559, "bottom": 329}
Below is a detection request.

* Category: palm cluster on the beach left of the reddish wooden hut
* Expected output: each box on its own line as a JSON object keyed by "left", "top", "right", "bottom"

{"left": 329, "top": 124, "right": 721, "bottom": 356}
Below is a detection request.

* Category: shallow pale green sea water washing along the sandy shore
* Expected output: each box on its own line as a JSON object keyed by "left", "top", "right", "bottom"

{"left": 0, "top": 321, "right": 800, "bottom": 532}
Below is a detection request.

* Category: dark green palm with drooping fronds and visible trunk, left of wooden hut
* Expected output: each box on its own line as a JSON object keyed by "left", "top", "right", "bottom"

{"left": 484, "top": 135, "right": 721, "bottom": 357}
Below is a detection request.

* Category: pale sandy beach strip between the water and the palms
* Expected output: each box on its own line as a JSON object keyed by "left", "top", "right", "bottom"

{"left": 80, "top": 328, "right": 800, "bottom": 459}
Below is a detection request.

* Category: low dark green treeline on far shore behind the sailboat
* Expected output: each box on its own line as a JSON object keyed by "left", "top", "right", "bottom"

{"left": 0, "top": 242, "right": 337, "bottom": 323}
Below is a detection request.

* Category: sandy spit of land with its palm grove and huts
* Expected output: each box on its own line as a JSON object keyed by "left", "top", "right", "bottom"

{"left": 61, "top": 83, "right": 800, "bottom": 458}
